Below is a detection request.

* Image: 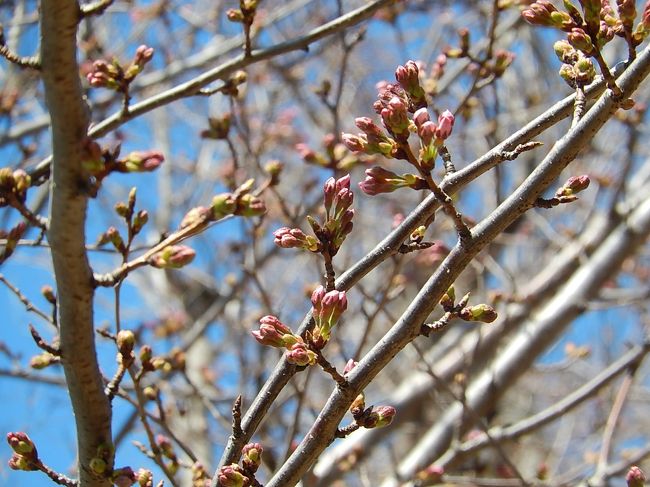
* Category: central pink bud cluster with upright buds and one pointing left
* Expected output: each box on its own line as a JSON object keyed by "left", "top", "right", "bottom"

{"left": 273, "top": 174, "right": 354, "bottom": 256}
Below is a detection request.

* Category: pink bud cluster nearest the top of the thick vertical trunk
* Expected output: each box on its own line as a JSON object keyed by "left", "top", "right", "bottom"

{"left": 86, "top": 45, "right": 154, "bottom": 93}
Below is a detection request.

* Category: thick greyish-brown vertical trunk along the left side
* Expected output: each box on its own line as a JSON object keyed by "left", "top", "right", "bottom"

{"left": 41, "top": 0, "right": 111, "bottom": 486}
